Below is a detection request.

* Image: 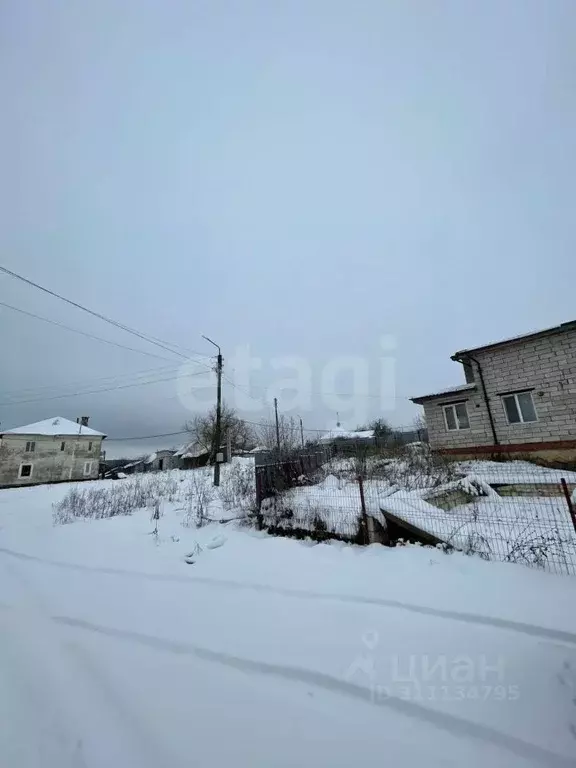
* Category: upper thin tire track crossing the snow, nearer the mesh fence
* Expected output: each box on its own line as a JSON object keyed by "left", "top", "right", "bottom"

{"left": 0, "top": 547, "right": 576, "bottom": 645}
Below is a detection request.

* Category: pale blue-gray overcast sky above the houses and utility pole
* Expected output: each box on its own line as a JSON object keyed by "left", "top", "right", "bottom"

{"left": 0, "top": 0, "right": 576, "bottom": 455}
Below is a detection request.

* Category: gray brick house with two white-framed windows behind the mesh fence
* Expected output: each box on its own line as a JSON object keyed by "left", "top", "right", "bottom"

{"left": 411, "top": 321, "right": 576, "bottom": 461}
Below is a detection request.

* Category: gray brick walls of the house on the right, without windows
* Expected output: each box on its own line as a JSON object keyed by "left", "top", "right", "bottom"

{"left": 424, "top": 331, "right": 576, "bottom": 448}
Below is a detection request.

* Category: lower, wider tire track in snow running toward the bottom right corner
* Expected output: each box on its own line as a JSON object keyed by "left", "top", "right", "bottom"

{"left": 52, "top": 616, "right": 576, "bottom": 768}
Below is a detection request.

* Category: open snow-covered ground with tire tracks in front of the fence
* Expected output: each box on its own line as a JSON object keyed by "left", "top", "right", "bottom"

{"left": 0, "top": 464, "right": 576, "bottom": 768}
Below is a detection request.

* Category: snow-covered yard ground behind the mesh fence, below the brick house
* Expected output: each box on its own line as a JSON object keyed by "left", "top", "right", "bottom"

{"left": 261, "top": 456, "right": 576, "bottom": 575}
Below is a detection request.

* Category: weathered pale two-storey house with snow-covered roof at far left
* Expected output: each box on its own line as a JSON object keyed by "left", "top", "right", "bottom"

{"left": 0, "top": 416, "right": 106, "bottom": 488}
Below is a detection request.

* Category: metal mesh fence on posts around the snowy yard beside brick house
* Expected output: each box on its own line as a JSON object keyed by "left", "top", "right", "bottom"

{"left": 256, "top": 446, "right": 576, "bottom": 574}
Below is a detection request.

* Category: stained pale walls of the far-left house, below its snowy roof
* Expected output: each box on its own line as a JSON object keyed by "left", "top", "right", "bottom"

{"left": 0, "top": 435, "right": 102, "bottom": 486}
